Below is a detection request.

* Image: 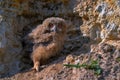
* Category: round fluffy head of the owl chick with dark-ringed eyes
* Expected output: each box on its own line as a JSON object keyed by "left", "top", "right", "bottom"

{"left": 43, "top": 17, "right": 66, "bottom": 34}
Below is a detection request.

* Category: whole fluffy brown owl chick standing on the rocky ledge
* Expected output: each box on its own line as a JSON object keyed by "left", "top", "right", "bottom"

{"left": 29, "top": 17, "right": 67, "bottom": 71}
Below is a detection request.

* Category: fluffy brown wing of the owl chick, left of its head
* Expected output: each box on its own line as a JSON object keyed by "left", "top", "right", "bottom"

{"left": 28, "top": 25, "right": 53, "bottom": 44}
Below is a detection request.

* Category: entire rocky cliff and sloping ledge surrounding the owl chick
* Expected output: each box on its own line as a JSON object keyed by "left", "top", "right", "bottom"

{"left": 0, "top": 0, "right": 120, "bottom": 80}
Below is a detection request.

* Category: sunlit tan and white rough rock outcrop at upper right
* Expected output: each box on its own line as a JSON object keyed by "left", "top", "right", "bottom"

{"left": 74, "top": 0, "right": 120, "bottom": 42}
